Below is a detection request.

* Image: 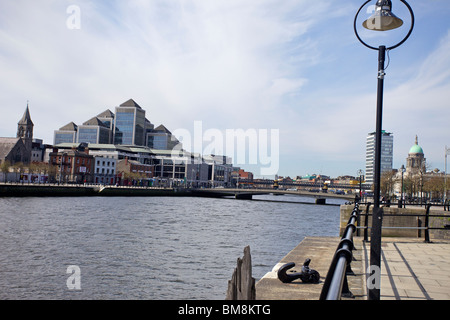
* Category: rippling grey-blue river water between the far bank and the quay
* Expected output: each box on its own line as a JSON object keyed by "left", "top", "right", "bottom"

{"left": 0, "top": 195, "right": 339, "bottom": 300}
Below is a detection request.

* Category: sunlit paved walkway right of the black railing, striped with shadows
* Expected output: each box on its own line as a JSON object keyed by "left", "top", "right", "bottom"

{"left": 355, "top": 237, "right": 450, "bottom": 300}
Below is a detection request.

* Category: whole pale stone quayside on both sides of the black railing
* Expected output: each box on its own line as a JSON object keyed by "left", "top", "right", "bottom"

{"left": 256, "top": 237, "right": 450, "bottom": 300}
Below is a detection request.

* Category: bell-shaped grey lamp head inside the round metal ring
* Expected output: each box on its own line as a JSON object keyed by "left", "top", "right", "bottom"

{"left": 363, "top": 0, "right": 403, "bottom": 31}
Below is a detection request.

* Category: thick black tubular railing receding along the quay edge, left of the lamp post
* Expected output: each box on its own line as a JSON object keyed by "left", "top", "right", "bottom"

{"left": 320, "top": 203, "right": 359, "bottom": 300}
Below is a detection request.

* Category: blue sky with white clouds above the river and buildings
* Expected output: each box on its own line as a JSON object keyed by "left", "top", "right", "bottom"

{"left": 0, "top": 0, "right": 450, "bottom": 177}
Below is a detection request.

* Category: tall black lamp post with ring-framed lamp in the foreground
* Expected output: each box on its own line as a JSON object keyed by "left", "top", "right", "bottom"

{"left": 353, "top": 0, "right": 414, "bottom": 300}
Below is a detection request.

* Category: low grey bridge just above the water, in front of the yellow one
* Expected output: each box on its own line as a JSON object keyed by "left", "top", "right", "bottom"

{"left": 190, "top": 188, "right": 355, "bottom": 204}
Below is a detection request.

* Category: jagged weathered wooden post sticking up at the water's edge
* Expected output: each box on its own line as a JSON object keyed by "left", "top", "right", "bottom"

{"left": 225, "top": 246, "right": 256, "bottom": 300}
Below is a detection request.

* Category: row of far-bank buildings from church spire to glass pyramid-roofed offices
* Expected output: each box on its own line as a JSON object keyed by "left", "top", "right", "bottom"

{"left": 0, "top": 99, "right": 253, "bottom": 187}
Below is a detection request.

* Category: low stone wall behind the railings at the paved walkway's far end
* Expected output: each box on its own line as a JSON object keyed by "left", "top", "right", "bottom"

{"left": 339, "top": 205, "right": 450, "bottom": 240}
